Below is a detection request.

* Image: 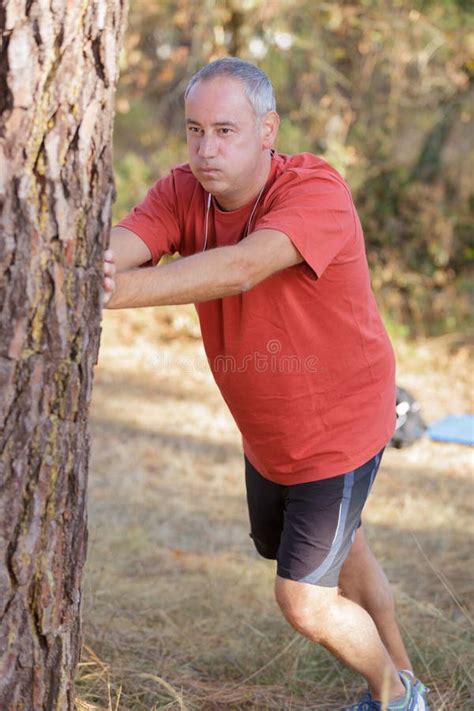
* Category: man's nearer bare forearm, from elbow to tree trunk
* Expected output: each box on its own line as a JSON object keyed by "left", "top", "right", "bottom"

{"left": 106, "top": 247, "right": 251, "bottom": 309}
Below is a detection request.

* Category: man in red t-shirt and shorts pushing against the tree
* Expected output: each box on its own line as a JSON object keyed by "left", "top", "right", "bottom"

{"left": 104, "top": 57, "right": 428, "bottom": 711}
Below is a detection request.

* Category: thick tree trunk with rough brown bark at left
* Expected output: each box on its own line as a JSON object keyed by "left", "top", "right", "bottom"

{"left": 0, "top": 0, "right": 126, "bottom": 711}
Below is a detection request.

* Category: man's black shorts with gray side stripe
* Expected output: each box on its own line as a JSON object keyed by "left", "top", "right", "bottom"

{"left": 245, "top": 449, "right": 383, "bottom": 587}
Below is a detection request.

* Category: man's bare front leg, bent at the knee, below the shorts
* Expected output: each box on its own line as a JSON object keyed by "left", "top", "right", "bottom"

{"left": 275, "top": 576, "right": 405, "bottom": 701}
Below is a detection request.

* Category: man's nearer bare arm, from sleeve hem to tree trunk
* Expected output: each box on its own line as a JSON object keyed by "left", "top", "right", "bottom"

{"left": 104, "top": 229, "right": 303, "bottom": 309}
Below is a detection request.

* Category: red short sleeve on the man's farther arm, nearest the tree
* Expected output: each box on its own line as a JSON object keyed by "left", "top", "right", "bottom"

{"left": 117, "top": 173, "right": 180, "bottom": 265}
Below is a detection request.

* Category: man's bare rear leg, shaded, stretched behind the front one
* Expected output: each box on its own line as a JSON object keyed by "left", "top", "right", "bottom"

{"left": 339, "top": 526, "right": 413, "bottom": 671}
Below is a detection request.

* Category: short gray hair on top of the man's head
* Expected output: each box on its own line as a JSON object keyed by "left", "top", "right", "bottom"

{"left": 184, "top": 57, "right": 276, "bottom": 118}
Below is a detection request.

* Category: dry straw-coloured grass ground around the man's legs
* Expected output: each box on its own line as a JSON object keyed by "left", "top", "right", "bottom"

{"left": 77, "top": 307, "right": 474, "bottom": 711}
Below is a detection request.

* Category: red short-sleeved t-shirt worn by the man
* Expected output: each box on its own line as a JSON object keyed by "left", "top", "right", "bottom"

{"left": 119, "top": 153, "right": 395, "bottom": 485}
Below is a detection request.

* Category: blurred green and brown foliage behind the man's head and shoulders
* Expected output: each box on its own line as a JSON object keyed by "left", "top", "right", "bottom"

{"left": 114, "top": 0, "right": 474, "bottom": 336}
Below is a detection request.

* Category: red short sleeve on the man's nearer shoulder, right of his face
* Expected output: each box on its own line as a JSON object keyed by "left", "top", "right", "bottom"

{"left": 255, "top": 168, "right": 356, "bottom": 277}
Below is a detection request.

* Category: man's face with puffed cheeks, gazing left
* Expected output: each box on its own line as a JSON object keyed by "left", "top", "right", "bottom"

{"left": 185, "top": 76, "right": 269, "bottom": 209}
